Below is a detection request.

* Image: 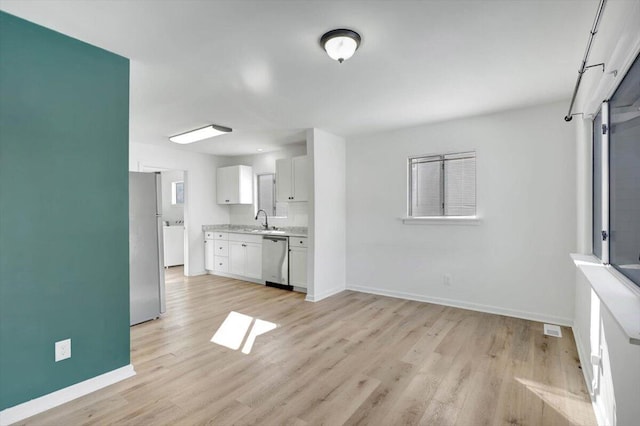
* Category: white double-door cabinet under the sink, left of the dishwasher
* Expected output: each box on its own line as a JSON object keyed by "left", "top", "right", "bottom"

{"left": 228, "top": 233, "right": 262, "bottom": 280}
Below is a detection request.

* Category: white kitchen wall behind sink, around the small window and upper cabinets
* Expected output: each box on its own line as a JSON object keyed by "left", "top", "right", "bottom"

{"left": 221, "top": 144, "right": 309, "bottom": 227}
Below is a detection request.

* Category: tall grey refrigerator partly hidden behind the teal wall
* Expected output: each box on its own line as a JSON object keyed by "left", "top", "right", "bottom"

{"left": 129, "top": 172, "right": 166, "bottom": 325}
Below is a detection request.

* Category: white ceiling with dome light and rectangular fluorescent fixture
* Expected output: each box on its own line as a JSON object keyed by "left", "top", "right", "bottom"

{"left": 0, "top": 0, "right": 598, "bottom": 155}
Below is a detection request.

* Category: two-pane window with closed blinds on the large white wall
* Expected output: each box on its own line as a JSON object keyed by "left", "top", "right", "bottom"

{"left": 408, "top": 152, "right": 476, "bottom": 217}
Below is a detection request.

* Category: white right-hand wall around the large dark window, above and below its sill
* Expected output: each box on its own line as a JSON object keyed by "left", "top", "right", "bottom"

{"left": 573, "top": 0, "right": 640, "bottom": 426}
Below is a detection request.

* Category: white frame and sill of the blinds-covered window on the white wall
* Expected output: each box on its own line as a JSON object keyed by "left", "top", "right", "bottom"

{"left": 410, "top": 149, "right": 478, "bottom": 218}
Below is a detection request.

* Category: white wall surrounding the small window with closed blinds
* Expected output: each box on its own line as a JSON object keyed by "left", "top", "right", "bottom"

{"left": 347, "top": 102, "right": 576, "bottom": 324}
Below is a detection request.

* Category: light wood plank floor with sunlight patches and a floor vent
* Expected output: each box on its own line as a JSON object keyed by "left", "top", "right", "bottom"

{"left": 24, "top": 268, "right": 596, "bottom": 426}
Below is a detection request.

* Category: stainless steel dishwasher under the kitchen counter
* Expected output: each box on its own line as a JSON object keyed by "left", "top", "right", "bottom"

{"left": 262, "top": 235, "right": 293, "bottom": 290}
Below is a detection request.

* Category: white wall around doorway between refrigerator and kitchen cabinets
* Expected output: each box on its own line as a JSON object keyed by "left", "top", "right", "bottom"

{"left": 129, "top": 142, "right": 229, "bottom": 275}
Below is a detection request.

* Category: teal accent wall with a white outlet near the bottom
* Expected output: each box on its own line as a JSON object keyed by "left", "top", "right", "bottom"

{"left": 0, "top": 12, "right": 129, "bottom": 409}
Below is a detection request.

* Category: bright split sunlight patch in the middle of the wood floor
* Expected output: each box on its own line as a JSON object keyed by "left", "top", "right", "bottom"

{"left": 211, "top": 311, "right": 278, "bottom": 354}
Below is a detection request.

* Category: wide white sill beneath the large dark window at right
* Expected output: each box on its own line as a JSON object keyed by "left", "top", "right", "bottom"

{"left": 571, "top": 253, "right": 640, "bottom": 345}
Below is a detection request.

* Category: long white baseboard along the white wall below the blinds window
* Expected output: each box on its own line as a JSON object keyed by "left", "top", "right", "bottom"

{"left": 347, "top": 285, "right": 573, "bottom": 327}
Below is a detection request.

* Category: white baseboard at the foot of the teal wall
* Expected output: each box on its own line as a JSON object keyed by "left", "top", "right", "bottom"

{"left": 0, "top": 364, "right": 136, "bottom": 426}
